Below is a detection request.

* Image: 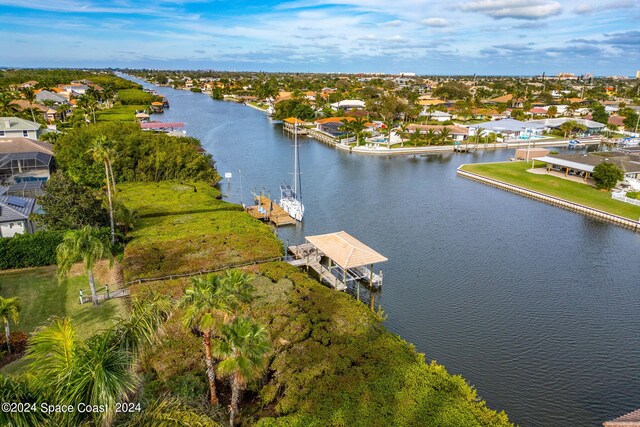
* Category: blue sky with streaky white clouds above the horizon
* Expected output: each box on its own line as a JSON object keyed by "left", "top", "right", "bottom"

{"left": 0, "top": 0, "right": 640, "bottom": 76}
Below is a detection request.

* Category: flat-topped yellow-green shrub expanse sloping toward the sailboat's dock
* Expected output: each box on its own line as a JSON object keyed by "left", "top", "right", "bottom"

{"left": 118, "top": 182, "right": 281, "bottom": 281}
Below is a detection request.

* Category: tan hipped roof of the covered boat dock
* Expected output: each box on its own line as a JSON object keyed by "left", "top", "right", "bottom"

{"left": 306, "top": 231, "right": 387, "bottom": 268}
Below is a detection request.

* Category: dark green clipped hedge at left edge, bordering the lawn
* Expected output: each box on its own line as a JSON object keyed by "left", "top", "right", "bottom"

{"left": 0, "top": 231, "right": 64, "bottom": 270}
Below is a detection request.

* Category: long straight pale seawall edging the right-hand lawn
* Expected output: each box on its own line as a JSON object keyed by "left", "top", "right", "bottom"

{"left": 456, "top": 165, "right": 640, "bottom": 232}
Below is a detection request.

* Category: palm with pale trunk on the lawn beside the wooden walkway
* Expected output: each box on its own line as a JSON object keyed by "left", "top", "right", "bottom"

{"left": 56, "top": 225, "right": 113, "bottom": 306}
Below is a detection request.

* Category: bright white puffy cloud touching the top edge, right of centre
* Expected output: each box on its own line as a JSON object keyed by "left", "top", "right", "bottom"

{"left": 461, "top": 0, "right": 562, "bottom": 19}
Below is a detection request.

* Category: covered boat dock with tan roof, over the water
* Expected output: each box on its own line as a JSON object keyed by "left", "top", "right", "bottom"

{"left": 287, "top": 231, "right": 387, "bottom": 295}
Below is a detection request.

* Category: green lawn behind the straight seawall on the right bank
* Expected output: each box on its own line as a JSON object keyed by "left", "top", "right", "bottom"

{"left": 462, "top": 162, "right": 640, "bottom": 221}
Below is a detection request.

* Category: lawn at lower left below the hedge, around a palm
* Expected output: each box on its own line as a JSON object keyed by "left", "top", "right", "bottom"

{"left": 0, "top": 266, "right": 126, "bottom": 373}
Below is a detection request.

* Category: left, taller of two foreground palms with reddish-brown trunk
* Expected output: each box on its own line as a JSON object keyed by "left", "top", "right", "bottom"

{"left": 179, "top": 270, "right": 253, "bottom": 406}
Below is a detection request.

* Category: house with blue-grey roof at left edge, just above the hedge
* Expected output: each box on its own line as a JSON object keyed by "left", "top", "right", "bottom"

{"left": 0, "top": 187, "right": 40, "bottom": 238}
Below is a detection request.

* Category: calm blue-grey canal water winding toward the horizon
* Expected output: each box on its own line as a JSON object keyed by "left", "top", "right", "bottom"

{"left": 126, "top": 77, "right": 640, "bottom": 426}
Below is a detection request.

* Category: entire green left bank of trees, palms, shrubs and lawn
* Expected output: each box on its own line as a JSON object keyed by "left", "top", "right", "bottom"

{"left": 0, "top": 70, "right": 511, "bottom": 426}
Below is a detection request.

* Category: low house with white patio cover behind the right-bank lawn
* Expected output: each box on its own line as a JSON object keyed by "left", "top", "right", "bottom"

{"left": 536, "top": 152, "right": 640, "bottom": 187}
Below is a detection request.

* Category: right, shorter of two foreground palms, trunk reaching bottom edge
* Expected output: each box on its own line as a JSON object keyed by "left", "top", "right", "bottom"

{"left": 214, "top": 317, "right": 270, "bottom": 426}
